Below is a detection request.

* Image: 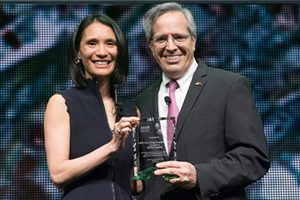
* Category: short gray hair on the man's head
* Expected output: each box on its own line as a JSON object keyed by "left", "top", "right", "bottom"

{"left": 143, "top": 2, "right": 196, "bottom": 41}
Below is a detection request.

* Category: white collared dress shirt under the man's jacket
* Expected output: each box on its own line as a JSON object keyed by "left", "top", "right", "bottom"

{"left": 158, "top": 59, "right": 198, "bottom": 153}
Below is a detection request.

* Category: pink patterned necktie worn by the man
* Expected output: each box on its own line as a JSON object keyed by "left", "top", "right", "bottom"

{"left": 167, "top": 81, "right": 179, "bottom": 153}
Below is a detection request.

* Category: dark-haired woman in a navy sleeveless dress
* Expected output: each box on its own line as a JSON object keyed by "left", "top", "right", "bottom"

{"left": 44, "top": 14, "right": 139, "bottom": 200}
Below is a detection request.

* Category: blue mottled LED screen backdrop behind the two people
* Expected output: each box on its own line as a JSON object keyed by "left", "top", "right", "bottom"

{"left": 0, "top": 1, "right": 300, "bottom": 200}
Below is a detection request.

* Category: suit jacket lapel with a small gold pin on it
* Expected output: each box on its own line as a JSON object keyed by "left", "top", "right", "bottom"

{"left": 176, "top": 61, "right": 207, "bottom": 138}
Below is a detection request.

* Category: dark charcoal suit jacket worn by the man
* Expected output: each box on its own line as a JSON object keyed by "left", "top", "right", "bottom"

{"left": 136, "top": 61, "right": 269, "bottom": 200}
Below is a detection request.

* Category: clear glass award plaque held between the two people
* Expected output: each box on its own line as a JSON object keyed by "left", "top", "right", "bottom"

{"left": 132, "top": 117, "right": 177, "bottom": 180}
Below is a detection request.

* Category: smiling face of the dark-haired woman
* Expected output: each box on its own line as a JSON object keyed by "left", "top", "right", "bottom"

{"left": 77, "top": 21, "right": 118, "bottom": 80}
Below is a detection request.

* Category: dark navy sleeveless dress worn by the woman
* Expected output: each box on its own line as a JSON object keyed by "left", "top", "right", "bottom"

{"left": 59, "top": 79, "right": 137, "bottom": 200}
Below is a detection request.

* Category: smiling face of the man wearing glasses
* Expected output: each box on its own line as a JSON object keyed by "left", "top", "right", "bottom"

{"left": 150, "top": 12, "right": 196, "bottom": 79}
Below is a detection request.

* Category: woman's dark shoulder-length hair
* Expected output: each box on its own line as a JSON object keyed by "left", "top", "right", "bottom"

{"left": 67, "top": 14, "right": 128, "bottom": 88}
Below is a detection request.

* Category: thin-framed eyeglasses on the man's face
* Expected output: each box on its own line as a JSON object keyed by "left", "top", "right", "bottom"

{"left": 151, "top": 34, "right": 190, "bottom": 47}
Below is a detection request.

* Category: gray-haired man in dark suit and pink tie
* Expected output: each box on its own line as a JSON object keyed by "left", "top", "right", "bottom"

{"left": 136, "top": 3, "right": 269, "bottom": 200}
